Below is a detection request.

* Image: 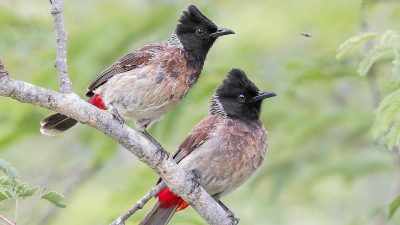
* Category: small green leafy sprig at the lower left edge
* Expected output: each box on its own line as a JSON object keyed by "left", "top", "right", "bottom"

{"left": 0, "top": 159, "right": 65, "bottom": 208}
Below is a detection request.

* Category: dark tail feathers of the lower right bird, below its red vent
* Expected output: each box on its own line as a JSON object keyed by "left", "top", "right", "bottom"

{"left": 139, "top": 201, "right": 178, "bottom": 225}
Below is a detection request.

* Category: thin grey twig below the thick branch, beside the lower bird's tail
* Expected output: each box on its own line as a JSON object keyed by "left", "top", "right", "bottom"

{"left": 110, "top": 182, "right": 165, "bottom": 225}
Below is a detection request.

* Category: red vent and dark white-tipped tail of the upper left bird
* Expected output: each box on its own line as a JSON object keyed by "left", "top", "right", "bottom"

{"left": 40, "top": 94, "right": 107, "bottom": 136}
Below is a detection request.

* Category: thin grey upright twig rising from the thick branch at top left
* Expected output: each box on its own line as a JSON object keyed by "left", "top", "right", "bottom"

{"left": 50, "top": 0, "right": 72, "bottom": 93}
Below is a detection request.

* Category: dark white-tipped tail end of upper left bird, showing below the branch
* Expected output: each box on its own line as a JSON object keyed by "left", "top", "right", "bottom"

{"left": 40, "top": 113, "right": 77, "bottom": 136}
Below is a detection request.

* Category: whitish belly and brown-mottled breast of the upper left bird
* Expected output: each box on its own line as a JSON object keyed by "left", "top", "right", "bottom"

{"left": 100, "top": 48, "right": 200, "bottom": 121}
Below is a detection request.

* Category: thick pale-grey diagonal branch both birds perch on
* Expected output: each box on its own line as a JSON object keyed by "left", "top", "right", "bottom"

{"left": 0, "top": 76, "right": 234, "bottom": 225}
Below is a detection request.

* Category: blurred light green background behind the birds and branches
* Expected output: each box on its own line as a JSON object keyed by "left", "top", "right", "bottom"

{"left": 0, "top": 0, "right": 400, "bottom": 225}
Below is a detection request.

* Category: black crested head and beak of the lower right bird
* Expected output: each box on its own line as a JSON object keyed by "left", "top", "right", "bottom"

{"left": 210, "top": 69, "right": 276, "bottom": 120}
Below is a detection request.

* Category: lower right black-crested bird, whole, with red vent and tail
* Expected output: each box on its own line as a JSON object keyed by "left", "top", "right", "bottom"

{"left": 140, "top": 69, "right": 276, "bottom": 225}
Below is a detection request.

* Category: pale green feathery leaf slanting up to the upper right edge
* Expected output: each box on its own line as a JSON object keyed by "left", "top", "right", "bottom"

{"left": 357, "top": 30, "right": 399, "bottom": 76}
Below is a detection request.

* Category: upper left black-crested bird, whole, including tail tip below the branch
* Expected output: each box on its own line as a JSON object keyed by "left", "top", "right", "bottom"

{"left": 40, "top": 5, "right": 234, "bottom": 146}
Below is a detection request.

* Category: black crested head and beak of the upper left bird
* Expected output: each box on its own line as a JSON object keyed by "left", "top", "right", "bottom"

{"left": 175, "top": 5, "right": 234, "bottom": 58}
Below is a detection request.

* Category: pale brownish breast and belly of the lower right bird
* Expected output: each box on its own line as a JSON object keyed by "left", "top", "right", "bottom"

{"left": 179, "top": 119, "right": 266, "bottom": 195}
